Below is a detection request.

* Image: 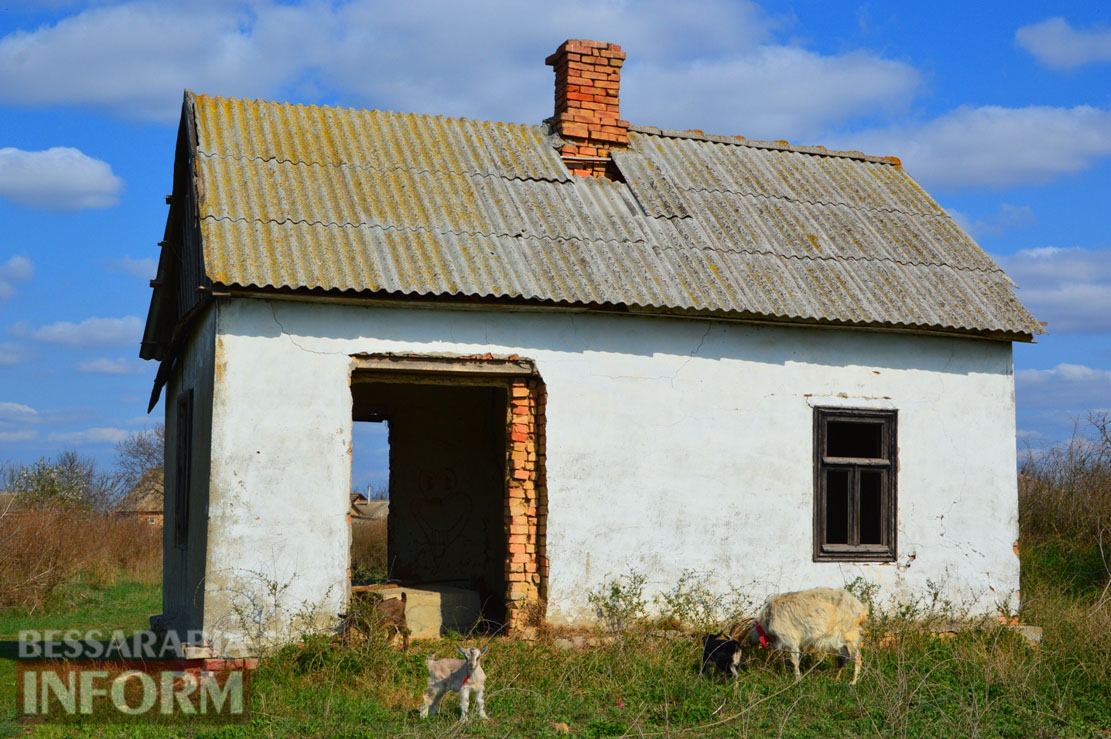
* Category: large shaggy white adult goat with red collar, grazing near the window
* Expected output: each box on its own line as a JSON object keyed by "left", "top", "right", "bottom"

{"left": 739, "top": 588, "right": 868, "bottom": 685}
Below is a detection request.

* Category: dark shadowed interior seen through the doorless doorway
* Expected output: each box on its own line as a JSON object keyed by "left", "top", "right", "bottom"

{"left": 351, "top": 377, "right": 507, "bottom": 623}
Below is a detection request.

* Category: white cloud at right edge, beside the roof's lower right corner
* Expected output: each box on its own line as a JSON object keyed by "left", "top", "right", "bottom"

{"left": 994, "top": 247, "right": 1111, "bottom": 333}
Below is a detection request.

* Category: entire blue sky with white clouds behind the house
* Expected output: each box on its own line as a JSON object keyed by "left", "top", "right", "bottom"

{"left": 0, "top": 0, "right": 1111, "bottom": 482}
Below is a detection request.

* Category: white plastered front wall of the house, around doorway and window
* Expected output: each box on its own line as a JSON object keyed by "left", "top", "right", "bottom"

{"left": 206, "top": 299, "right": 1019, "bottom": 644}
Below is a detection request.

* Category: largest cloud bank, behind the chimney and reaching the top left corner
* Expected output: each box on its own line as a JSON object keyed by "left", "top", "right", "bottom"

{"left": 0, "top": 0, "right": 920, "bottom": 138}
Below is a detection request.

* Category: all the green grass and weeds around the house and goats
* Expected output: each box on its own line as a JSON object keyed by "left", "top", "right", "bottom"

{"left": 0, "top": 555, "right": 1111, "bottom": 738}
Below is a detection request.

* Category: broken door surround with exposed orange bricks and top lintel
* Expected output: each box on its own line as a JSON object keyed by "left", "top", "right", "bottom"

{"left": 350, "top": 353, "right": 548, "bottom": 631}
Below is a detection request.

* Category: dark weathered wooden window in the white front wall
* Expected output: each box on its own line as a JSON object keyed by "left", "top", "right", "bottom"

{"left": 814, "top": 408, "right": 898, "bottom": 562}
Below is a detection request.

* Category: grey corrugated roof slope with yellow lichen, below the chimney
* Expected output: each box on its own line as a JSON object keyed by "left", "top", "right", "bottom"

{"left": 186, "top": 90, "right": 1041, "bottom": 338}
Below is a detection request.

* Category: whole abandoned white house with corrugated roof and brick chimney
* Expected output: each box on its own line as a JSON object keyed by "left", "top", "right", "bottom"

{"left": 141, "top": 41, "right": 1041, "bottom": 653}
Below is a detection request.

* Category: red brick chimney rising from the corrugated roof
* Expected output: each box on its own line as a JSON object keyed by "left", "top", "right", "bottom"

{"left": 544, "top": 39, "right": 629, "bottom": 177}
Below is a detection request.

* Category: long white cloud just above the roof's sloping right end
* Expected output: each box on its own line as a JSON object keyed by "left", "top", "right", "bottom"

{"left": 837, "top": 106, "right": 1111, "bottom": 188}
